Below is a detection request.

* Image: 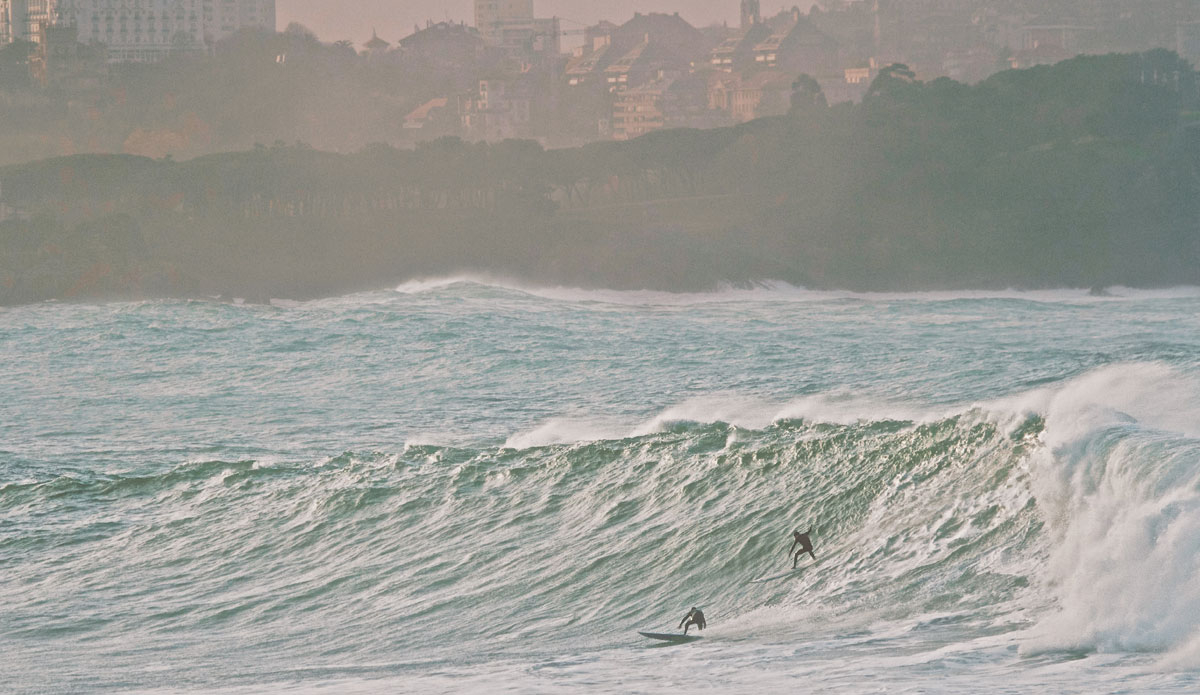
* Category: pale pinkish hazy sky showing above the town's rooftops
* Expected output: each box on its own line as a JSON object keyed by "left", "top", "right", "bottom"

{"left": 276, "top": 0, "right": 796, "bottom": 43}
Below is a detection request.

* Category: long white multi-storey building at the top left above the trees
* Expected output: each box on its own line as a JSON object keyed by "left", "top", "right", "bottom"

{"left": 0, "top": 0, "right": 275, "bottom": 62}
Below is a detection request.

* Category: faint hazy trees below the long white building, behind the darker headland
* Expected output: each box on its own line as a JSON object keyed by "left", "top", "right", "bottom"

{"left": 0, "top": 24, "right": 487, "bottom": 164}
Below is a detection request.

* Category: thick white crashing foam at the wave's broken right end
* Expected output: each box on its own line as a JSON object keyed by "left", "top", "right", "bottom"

{"left": 1024, "top": 364, "right": 1200, "bottom": 667}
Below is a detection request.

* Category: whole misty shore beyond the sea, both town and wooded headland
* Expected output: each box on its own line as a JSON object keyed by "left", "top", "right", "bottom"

{"left": 0, "top": 0, "right": 1200, "bottom": 304}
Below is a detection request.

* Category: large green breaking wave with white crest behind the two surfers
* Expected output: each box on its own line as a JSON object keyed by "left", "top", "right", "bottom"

{"left": 9, "top": 364, "right": 1200, "bottom": 686}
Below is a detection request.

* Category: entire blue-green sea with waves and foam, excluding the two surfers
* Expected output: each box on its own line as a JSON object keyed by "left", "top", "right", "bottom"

{"left": 0, "top": 276, "right": 1200, "bottom": 694}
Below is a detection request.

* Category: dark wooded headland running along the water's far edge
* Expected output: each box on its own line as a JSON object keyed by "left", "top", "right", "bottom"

{"left": 0, "top": 50, "right": 1200, "bottom": 302}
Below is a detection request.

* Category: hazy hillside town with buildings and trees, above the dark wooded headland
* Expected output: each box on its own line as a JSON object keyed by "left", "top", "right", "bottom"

{"left": 0, "top": 0, "right": 1200, "bottom": 161}
